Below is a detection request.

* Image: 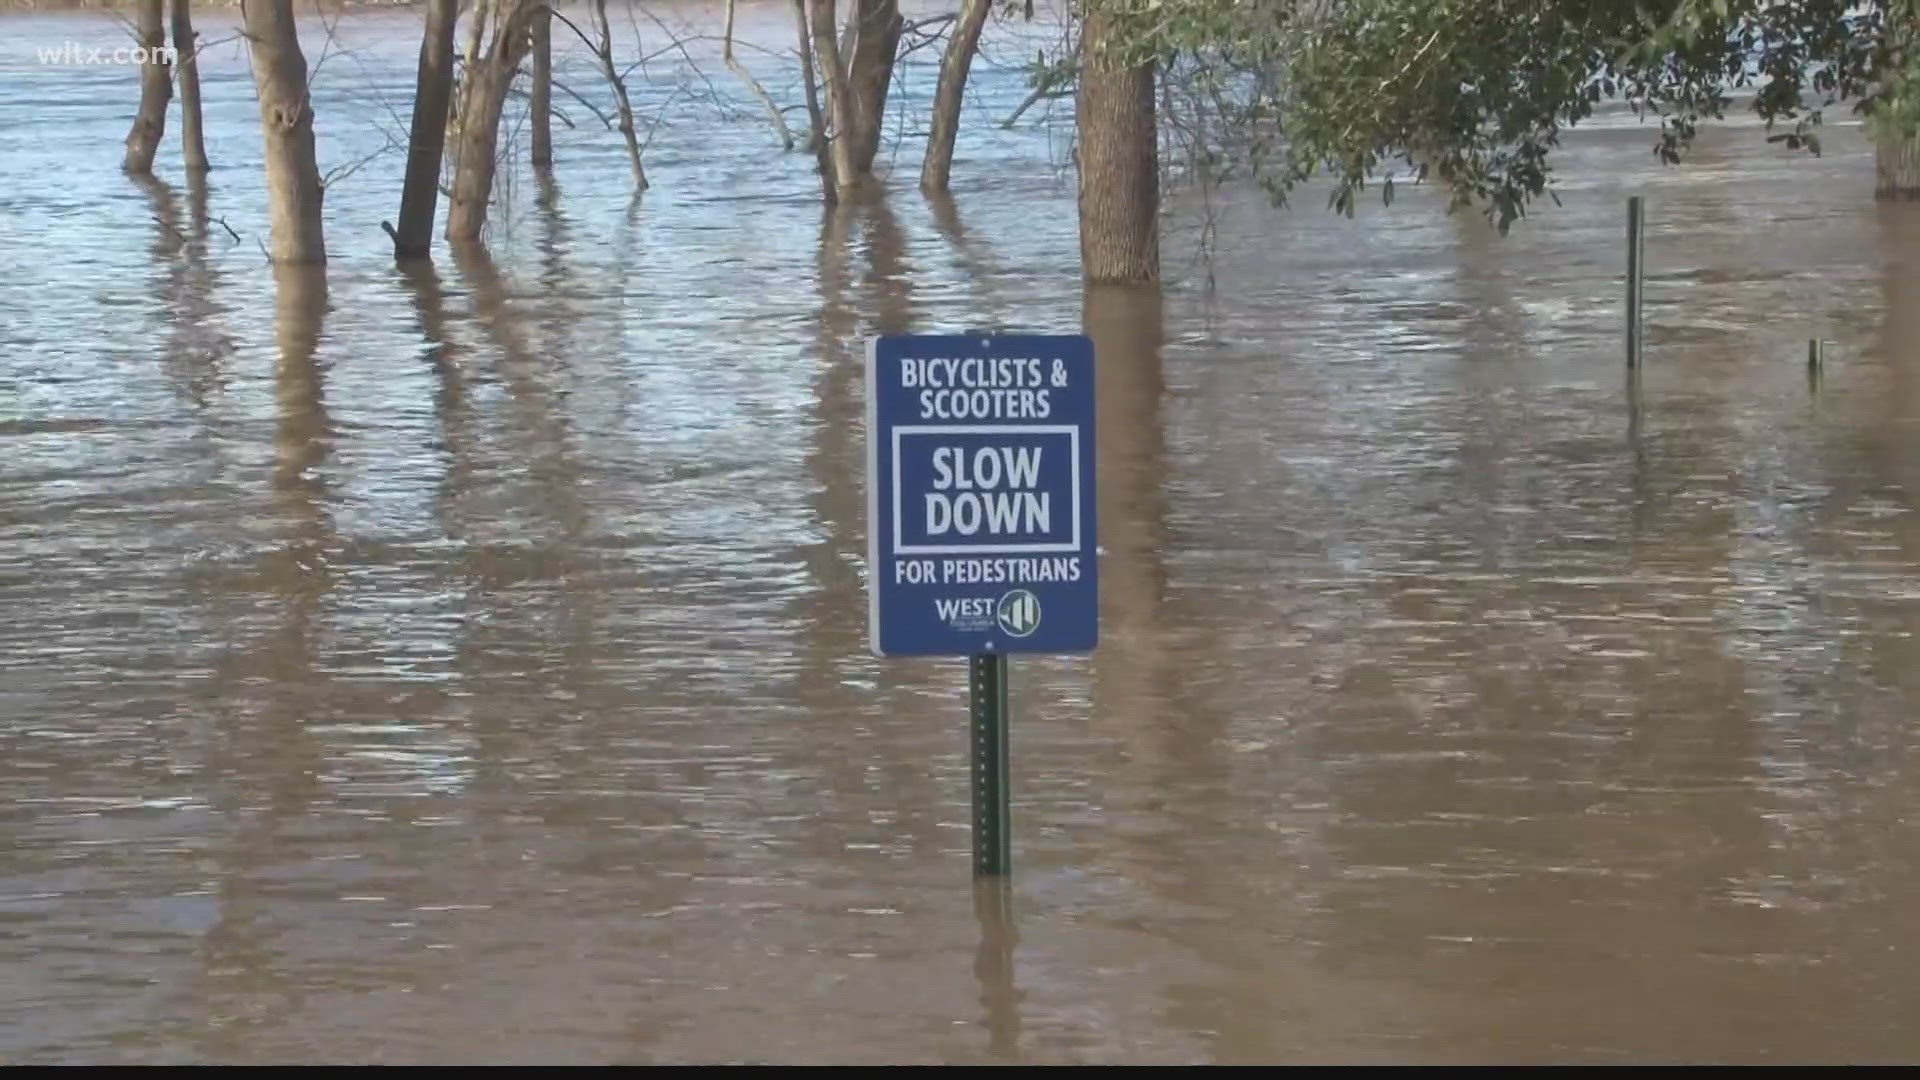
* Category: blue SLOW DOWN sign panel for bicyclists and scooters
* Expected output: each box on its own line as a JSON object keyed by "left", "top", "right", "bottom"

{"left": 866, "top": 334, "right": 1100, "bottom": 655}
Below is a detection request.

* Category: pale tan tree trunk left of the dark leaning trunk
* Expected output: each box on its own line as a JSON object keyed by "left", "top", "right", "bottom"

{"left": 240, "top": 0, "right": 326, "bottom": 265}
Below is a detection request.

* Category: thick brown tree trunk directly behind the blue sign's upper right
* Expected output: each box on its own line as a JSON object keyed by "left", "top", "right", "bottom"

{"left": 1075, "top": 12, "right": 1160, "bottom": 284}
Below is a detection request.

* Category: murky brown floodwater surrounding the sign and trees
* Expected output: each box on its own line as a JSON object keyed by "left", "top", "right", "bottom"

{"left": 0, "top": 4, "right": 1920, "bottom": 1063}
